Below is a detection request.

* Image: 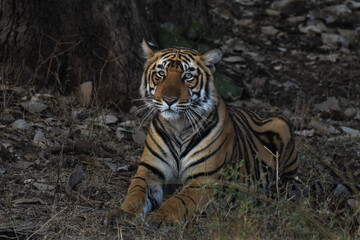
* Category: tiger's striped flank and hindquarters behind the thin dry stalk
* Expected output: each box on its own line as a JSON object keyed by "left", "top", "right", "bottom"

{"left": 227, "top": 105, "right": 299, "bottom": 188}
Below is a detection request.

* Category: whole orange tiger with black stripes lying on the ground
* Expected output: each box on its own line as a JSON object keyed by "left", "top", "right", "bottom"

{"left": 117, "top": 41, "right": 299, "bottom": 226}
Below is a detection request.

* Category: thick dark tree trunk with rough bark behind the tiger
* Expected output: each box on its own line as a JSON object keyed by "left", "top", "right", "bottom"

{"left": 0, "top": 0, "right": 207, "bottom": 108}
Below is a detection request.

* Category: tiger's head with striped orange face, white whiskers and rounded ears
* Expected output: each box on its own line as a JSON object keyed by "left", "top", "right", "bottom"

{"left": 140, "top": 41, "right": 222, "bottom": 123}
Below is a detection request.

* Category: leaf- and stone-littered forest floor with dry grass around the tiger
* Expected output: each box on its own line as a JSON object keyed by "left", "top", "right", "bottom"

{"left": 0, "top": 0, "right": 360, "bottom": 239}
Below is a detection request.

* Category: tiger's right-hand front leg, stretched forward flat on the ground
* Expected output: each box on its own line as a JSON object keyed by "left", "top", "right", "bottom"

{"left": 146, "top": 177, "right": 216, "bottom": 227}
